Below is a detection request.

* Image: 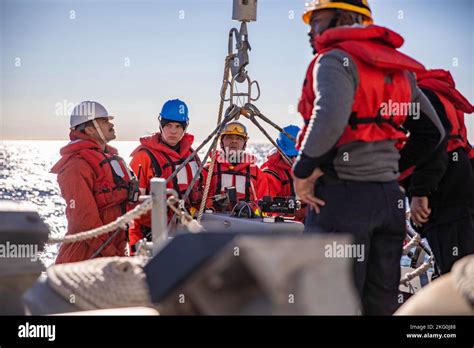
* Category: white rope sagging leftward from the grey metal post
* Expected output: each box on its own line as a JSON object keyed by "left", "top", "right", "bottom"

{"left": 48, "top": 198, "right": 153, "bottom": 244}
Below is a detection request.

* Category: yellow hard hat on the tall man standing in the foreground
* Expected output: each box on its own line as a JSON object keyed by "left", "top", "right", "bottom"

{"left": 303, "top": 0, "right": 374, "bottom": 24}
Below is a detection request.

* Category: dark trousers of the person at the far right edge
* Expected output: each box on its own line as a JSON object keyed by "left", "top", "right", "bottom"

{"left": 423, "top": 207, "right": 474, "bottom": 274}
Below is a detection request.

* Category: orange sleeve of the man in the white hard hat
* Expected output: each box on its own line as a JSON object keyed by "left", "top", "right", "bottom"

{"left": 58, "top": 158, "right": 121, "bottom": 256}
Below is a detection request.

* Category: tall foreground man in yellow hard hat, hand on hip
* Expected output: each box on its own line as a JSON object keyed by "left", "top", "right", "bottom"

{"left": 293, "top": 0, "right": 445, "bottom": 315}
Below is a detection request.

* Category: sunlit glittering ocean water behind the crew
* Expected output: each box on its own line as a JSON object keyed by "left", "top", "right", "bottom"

{"left": 0, "top": 140, "right": 272, "bottom": 267}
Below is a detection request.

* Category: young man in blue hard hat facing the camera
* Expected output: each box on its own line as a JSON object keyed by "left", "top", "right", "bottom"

{"left": 130, "top": 99, "right": 201, "bottom": 253}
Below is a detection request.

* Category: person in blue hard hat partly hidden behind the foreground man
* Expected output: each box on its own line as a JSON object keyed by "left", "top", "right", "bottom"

{"left": 260, "top": 125, "right": 305, "bottom": 221}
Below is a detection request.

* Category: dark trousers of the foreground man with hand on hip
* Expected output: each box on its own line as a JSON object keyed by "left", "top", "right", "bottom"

{"left": 305, "top": 181, "right": 406, "bottom": 315}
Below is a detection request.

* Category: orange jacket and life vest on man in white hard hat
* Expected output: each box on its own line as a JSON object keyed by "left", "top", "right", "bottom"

{"left": 51, "top": 130, "right": 133, "bottom": 264}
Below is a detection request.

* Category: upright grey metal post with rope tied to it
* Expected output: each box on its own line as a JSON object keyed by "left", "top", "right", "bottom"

{"left": 150, "top": 178, "right": 168, "bottom": 255}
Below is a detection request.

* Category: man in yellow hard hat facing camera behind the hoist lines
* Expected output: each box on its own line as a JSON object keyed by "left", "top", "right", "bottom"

{"left": 203, "top": 121, "right": 268, "bottom": 211}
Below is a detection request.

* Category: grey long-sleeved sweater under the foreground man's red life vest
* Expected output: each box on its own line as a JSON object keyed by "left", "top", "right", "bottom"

{"left": 294, "top": 50, "right": 445, "bottom": 182}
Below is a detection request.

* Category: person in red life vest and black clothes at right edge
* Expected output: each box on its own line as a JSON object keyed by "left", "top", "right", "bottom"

{"left": 405, "top": 69, "right": 474, "bottom": 274}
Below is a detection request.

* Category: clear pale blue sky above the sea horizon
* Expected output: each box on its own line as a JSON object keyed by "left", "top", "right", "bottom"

{"left": 0, "top": 0, "right": 474, "bottom": 142}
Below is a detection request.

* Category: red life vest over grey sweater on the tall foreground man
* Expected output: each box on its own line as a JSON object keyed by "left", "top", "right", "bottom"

{"left": 297, "top": 25, "right": 424, "bottom": 147}
